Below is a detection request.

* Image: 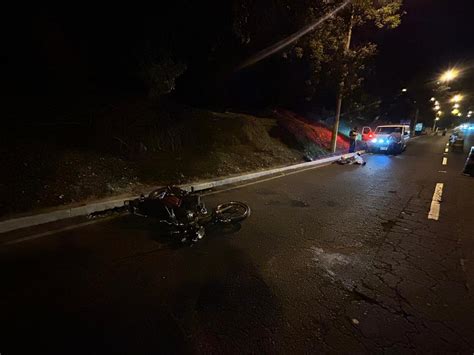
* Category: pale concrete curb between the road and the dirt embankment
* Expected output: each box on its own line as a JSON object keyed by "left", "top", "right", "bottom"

{"left": 0, "top": 151, "right": 364, "bottom": 234}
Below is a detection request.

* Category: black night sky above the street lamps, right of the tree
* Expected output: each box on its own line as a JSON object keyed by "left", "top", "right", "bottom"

{"left": 376, "top": 0, "right": 474, "bottom": 91}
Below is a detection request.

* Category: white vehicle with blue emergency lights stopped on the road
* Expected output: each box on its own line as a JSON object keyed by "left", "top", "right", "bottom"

{"left": 364, "top": 124, "right": 410, "bottom": 154}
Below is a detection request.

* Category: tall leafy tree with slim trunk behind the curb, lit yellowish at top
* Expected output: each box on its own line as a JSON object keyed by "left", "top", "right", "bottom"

{"left": 234, "top": 0, "right": 402, "bottom": 148}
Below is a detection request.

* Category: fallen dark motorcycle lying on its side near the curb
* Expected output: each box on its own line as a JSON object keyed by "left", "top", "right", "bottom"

{"left": 126, "top": 186, "right": 250, "bottom": 242}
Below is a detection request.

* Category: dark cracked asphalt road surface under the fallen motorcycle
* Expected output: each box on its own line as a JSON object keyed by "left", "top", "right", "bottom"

{"left": 0, "top": 132, "right": 474, "bottom": 355}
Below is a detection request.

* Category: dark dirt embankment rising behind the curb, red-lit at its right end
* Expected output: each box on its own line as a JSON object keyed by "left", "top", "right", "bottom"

{"left": 0, "top": 104, "right": 345, "bottom": 218}
